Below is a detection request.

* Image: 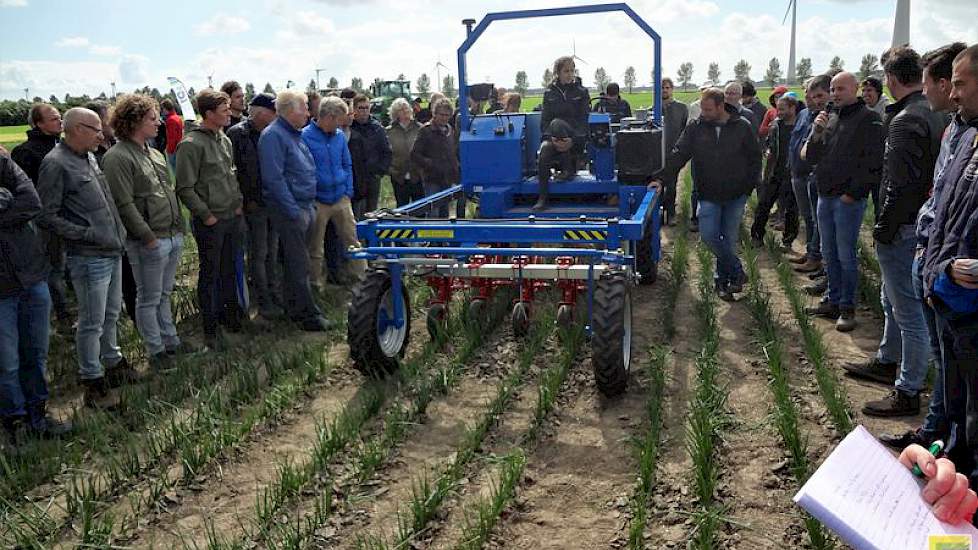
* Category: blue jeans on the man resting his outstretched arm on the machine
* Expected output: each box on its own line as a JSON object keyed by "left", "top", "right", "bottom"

{"left": 699, "top": 195, "right": 747, "bottom": 285}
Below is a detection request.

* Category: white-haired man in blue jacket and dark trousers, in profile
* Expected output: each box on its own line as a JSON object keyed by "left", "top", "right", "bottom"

{"left": 258, "top": 90, "right": 329, "bottom": 332}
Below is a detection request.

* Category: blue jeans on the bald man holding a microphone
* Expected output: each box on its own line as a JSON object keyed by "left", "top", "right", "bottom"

{"left": 818, "top": 196, "right": 864, "bottom": 308}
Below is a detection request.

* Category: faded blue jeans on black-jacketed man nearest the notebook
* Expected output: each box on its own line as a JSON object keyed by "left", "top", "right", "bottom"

{"left": 876, "top": 224, "right": 930, "bottom": 394}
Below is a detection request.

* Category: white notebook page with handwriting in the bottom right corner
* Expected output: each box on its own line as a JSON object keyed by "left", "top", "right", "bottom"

{"left": 794, "top": 426, "right": 978, "bottom": 550}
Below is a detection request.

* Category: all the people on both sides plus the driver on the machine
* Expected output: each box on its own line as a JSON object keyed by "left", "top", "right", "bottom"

{"left": 0, "top": 43, "right": 978, "bottom": 532}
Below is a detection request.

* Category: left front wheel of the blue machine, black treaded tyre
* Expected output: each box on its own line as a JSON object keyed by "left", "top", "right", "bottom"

{"left": 347, "top": 269, "right": 411, "bottom": 377}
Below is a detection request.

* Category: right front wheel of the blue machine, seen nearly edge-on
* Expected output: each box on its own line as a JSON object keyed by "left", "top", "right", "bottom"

{"left": 591, "top": 273, "right": 632, "bottom": 397}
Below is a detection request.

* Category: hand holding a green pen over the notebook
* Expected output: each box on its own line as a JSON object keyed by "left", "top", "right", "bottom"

{"left": 900, "top": 445, "right": 978, "bottom": 524}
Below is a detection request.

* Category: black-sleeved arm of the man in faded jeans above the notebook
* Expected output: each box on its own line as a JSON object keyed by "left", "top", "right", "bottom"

{"left": 873, "top": 113, "right": 927, "bottom": 244}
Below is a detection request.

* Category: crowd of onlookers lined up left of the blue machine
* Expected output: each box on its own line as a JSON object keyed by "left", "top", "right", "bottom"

{"left": 0, "top": 81, "right": 468, "bottom": 444}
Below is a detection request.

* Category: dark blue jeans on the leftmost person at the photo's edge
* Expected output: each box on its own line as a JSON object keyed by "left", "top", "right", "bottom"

{"left": 0, "top": 281, "right": 51, "bottom": 416}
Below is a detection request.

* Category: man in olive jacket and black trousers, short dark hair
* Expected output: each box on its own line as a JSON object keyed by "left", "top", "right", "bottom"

{"left": 176, "top": 90, "right": 244, "bottom": 351}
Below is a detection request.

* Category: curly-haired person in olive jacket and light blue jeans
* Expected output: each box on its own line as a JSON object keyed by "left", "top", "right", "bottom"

{"left": 102, "top": 94, "right": 186, "bottom": 372}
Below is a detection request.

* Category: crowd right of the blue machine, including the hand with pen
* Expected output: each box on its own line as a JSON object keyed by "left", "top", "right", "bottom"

{"left": 653, "top": 43, "right": 978, "bottom": 521}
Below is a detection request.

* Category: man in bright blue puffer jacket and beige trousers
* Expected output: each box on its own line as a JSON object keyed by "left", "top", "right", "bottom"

{"left": 302, "top": 97, "right": 366, "bottom": 288}
